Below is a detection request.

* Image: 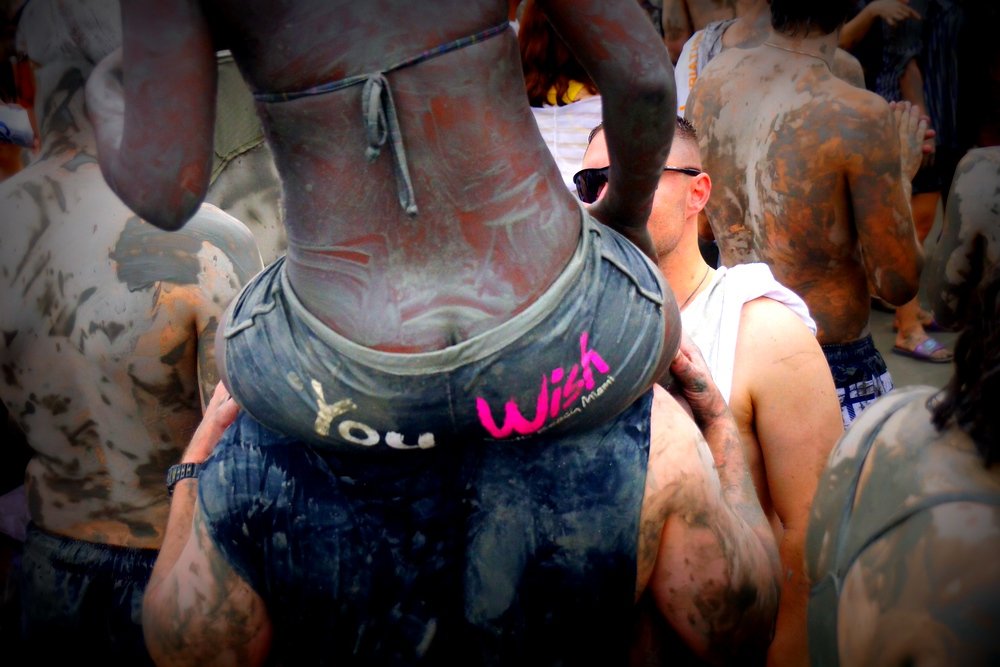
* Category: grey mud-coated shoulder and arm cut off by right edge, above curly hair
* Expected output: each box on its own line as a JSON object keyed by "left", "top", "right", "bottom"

{"left": 926, "top": 146, "right": 1000, "bottom": 327}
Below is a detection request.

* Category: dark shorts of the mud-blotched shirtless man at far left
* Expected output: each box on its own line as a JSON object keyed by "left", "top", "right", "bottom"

{"left": 20, "top": 524, "right": 159, "bottom": 665}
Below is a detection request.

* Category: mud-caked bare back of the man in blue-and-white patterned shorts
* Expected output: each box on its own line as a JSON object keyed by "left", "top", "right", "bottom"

{"left": 687, "top": 45, "right": 908, "bottom": 343}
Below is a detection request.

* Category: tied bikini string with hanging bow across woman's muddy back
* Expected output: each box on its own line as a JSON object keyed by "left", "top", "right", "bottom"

{"left": 253, "top": 21, "right": 510, "bottom": 217}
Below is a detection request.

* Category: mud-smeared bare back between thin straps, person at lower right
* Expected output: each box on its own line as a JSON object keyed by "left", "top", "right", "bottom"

{"left": 806, "top": 387, "right": 1000, "bottom": 665}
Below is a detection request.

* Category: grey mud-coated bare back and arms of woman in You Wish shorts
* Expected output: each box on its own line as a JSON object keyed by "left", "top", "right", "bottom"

{"left": 94, "top": 0, "right": 674, "bottom": 351}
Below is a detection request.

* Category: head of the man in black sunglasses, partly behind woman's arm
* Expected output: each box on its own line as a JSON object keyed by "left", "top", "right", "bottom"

{"left": 574, "top": 116, "right": 712, "bottom": 258}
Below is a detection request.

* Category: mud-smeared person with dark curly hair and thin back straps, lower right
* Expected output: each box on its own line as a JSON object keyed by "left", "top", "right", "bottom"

{"left": 806, "top": 262, "right": 1000, "bottom": 665}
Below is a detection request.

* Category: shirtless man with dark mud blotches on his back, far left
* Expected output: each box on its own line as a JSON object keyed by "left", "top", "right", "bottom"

{"left": 0, "top": 0, "right": 260, "bottom": 664}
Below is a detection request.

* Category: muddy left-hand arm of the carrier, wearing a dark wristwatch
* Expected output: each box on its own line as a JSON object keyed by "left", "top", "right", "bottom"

{"left": 142, "top": 383, "right": 271, "bottom": 667}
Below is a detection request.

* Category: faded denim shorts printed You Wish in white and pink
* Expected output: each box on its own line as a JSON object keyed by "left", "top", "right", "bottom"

{"left": 223, "top": 209, "right": 680, "bottom": 451}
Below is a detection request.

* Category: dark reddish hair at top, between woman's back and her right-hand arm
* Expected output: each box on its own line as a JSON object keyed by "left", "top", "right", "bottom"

{"left": 517, "top": 0, "right": 597, "bottom": 107}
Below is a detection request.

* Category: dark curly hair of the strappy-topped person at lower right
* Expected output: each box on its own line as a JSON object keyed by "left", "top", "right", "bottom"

{"left": 929, "top": 264, "right": 1000, "bottom": 467}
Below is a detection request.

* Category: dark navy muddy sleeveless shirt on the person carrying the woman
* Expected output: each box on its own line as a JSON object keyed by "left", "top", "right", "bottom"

{"left": 198, "top": 391, "right": 653, "bottom": 665}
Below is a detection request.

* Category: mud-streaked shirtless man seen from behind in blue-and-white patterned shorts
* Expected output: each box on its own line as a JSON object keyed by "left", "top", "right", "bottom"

{"left": 686, "top": 0, "right": 926, "bottom": 427}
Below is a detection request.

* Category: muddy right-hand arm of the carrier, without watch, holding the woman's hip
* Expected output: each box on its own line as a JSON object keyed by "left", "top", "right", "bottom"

{"left": 647, "top": 341, "right": 779, "bottom": 664}
